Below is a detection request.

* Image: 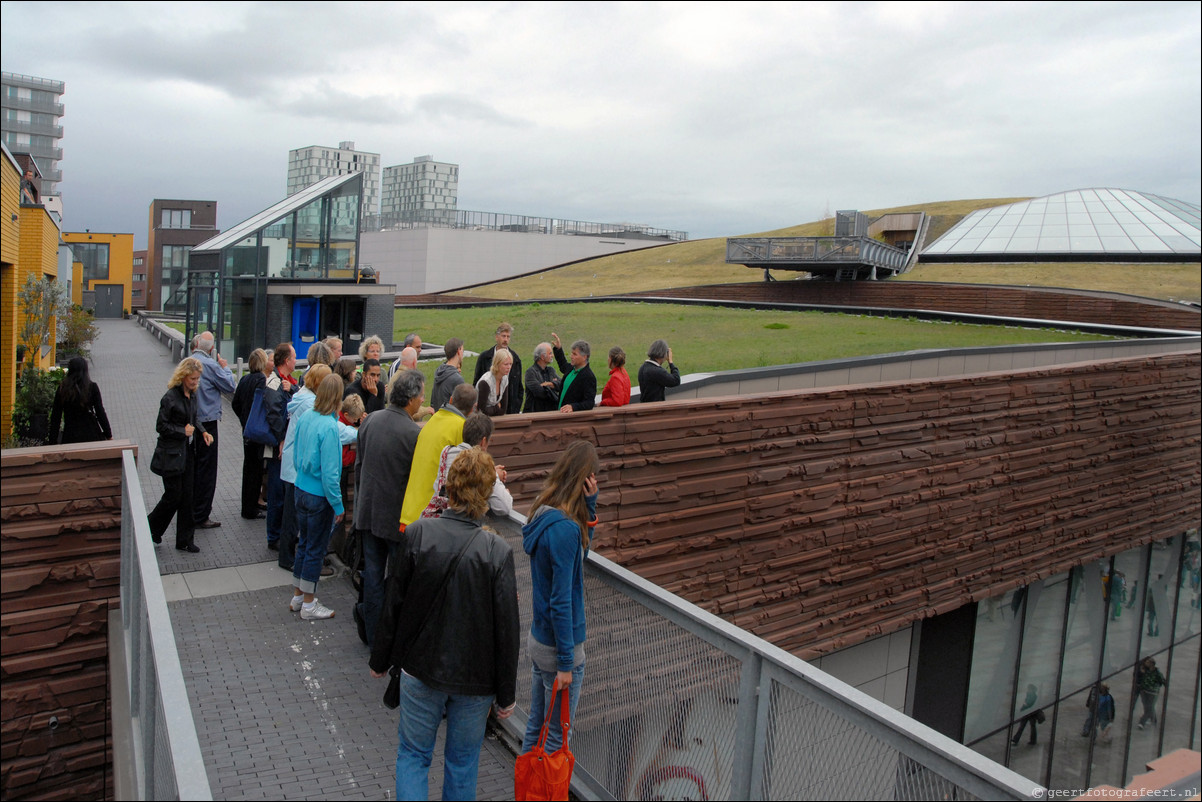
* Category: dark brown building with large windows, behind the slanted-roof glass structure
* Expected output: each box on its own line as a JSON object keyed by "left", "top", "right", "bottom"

{"left": 145, "top": 198, "right": 218, "bottom": 315}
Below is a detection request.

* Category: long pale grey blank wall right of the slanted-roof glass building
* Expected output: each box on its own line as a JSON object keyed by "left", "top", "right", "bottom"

{"left": 359, "top": 228, "right": 665, "bottom": 295}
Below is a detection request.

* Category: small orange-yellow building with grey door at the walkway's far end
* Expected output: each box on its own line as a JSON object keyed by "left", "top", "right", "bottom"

{"left": 63, "top": 231, "right": 133, "bottom": 317}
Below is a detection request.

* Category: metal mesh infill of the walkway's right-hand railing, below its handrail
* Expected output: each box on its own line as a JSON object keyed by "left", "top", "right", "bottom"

{"left": 492, "top": 519, "right": 1025, "bottom": 800}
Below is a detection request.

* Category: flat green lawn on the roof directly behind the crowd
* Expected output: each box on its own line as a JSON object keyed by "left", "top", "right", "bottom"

{"left": 393, "top": 303, "right": 1108, "bottom": 386}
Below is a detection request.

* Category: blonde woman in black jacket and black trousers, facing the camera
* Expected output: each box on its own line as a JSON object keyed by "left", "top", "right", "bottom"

{"left": 147, "top": 357, "right": 213, "bottom": 554}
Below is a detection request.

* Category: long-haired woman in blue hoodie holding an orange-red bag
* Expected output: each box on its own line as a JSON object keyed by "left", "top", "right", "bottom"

{"left": 522, "top": 440, "right": 600, "bottom": 753}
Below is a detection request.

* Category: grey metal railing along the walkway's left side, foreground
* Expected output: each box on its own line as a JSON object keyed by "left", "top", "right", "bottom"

{"left": 112, "top": 451, "right": 213, "bottom": 800}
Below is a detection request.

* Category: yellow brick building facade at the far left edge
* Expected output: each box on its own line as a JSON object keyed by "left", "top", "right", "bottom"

{"left": 0, "top": 148, "right": 61, "bottom": 439}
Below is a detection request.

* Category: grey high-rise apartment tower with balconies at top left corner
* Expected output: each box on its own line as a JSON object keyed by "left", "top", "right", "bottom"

{"left": 0, "top": 72, "right": 64, "bottom": 196}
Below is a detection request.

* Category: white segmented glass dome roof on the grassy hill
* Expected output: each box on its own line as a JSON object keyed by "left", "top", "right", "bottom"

{"left": 922, "top": 189, "right": 1202, "bottom": 259}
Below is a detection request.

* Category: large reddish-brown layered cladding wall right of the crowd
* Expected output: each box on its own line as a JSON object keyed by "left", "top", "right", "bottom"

{"left": 489, "top": 351, "right": 1202, "bottom": 658}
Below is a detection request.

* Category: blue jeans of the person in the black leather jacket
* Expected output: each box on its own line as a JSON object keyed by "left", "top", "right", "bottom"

{"left": 397, "top": 672, "right": 493, "bottom": 800}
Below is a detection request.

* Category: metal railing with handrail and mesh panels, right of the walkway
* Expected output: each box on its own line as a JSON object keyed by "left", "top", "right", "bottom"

{"left": 488, "top": 515, "right": 1045, "bottom": 800}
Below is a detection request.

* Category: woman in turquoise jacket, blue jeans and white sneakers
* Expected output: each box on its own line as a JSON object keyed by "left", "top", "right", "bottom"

{"left": 288, "top": 375, "right": 343, "bottom": 620}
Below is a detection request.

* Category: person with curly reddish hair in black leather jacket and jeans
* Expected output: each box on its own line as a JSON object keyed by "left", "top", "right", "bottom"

{"left": 369, "top": 448, "right": 520, "bottom": 800}
